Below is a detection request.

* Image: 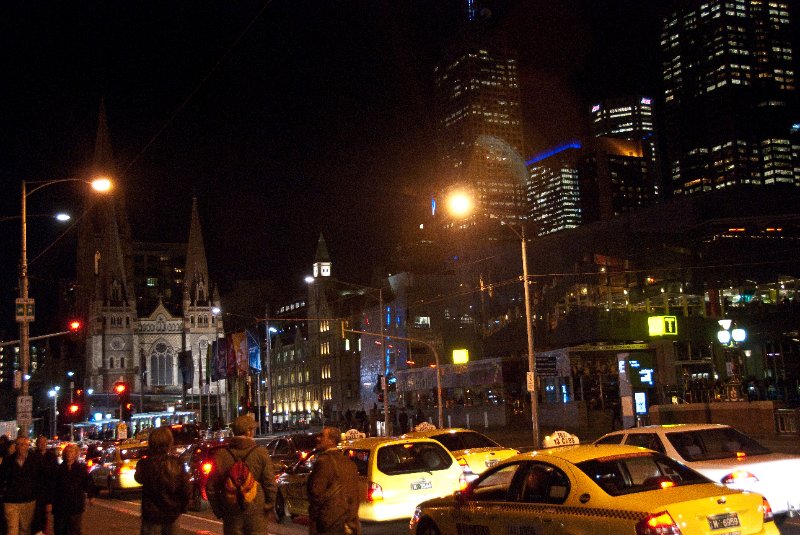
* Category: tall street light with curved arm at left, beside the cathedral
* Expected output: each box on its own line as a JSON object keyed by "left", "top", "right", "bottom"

{"left": 17, "top": 177, "right": 111, "bottom": 435}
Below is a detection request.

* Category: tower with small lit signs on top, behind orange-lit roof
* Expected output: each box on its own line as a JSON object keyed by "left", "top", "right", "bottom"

{"left": 592, "top": 95, "right": 661, "bottom": 199}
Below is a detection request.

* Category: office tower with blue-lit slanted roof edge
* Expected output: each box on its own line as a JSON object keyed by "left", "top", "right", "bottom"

{"left": 526, "top": 141, "right": 582, "bottom": 236}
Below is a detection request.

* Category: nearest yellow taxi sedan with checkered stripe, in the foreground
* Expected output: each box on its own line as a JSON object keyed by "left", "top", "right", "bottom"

{"left": 409, "top": 445, "right": 779, "bottom": 535}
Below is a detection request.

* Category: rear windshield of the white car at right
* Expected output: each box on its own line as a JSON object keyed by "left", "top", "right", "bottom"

{"left": 667, "top": 427, "right": 771, "bottom": 462}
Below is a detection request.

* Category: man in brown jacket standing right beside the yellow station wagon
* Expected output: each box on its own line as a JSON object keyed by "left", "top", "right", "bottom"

{"left": 307, "top": 427, "right": 361, "bottom": 535}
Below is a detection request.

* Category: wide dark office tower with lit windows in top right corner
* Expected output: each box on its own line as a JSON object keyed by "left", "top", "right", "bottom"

{"left": 661, "top": 0, "right": 799, "bottom": 194}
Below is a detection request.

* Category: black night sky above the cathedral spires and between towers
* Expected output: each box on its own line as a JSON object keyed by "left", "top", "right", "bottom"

{"left": 0, "top": 0, "right": 663, "bottom": 332}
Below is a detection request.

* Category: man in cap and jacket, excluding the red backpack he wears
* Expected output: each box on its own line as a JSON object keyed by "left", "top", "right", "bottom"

{"left": 208, "top": 414, "right": 275, "bottom": 535}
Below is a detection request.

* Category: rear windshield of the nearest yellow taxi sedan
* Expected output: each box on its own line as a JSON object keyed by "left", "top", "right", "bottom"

{"left": 577, "top": 452, "right": 710, "bottom": 496}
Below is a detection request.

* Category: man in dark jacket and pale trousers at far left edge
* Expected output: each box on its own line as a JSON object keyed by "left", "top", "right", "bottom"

{"left": 0, "top": 436, "right": 40, "bottom": 535}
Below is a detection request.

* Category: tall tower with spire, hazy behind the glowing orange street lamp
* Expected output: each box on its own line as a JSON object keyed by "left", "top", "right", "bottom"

{"left": 435, "top": 5, "right": 527, "bottom": 228}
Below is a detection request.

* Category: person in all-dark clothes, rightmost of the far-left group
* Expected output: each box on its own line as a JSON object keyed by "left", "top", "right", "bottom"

{"left": 51, "top": 444, "right": 94, "bottom": 535}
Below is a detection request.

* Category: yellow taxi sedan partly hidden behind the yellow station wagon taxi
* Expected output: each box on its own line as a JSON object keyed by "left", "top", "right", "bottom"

{"left": 403, "top": 424, "right": 519, "bottom": 475}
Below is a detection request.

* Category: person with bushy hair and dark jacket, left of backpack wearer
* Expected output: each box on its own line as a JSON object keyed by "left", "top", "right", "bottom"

{"left": 134, "top": 426, "right": 191, "bottom": 535}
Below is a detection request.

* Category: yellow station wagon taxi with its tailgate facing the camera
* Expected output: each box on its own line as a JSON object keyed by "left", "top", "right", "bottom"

{"left": 340, "top": 437, "right": 467, "bottom": 522}
